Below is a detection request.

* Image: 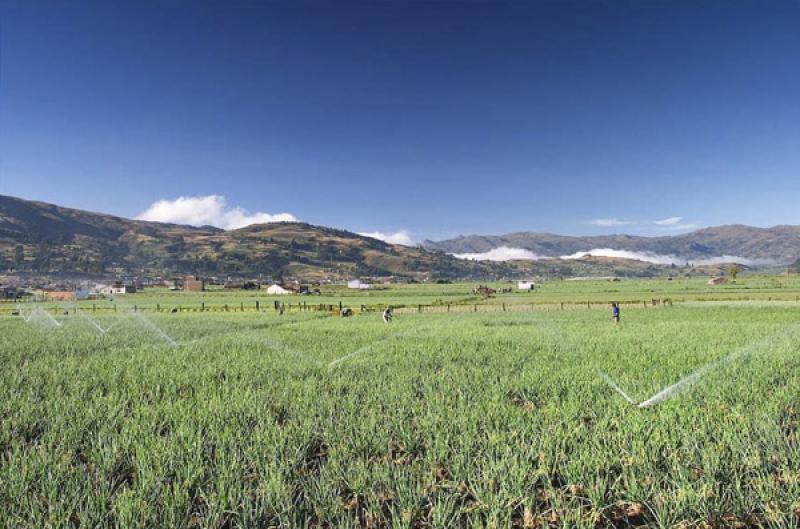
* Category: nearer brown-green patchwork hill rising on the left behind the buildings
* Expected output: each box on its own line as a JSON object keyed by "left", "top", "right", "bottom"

{"left": 0, "top": 195, "right": 494, "bottom": 279}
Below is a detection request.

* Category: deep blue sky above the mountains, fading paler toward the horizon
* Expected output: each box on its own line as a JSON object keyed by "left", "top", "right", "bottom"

{"left": 0, "top": 0, "right": 800, "bottom": 240}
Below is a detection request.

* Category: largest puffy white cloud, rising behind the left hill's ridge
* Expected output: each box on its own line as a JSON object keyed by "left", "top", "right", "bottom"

{"left": 136, "top": 195, "right": 297, "bottom": 230}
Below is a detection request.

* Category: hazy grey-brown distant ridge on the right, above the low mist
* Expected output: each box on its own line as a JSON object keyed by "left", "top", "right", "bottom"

{"left": 423, "top": 225, "right": 800, "bottom": 266}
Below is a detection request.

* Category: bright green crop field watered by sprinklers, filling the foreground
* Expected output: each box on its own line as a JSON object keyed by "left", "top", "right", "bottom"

{"left": 0, "top": 278, "right": 800, "bottom": 528}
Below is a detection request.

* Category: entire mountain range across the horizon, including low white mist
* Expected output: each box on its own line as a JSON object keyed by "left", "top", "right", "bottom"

{"left": 0, "top": 195, "right": 800, "bottom": 281}
